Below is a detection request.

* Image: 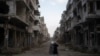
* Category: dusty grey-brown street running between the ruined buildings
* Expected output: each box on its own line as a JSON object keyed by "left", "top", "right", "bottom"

{"left": 0, "top": 42, "right": 100, "bottom": 56}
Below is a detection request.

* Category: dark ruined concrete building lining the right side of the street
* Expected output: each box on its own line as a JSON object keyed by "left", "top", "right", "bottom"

{"left": 60, "top": 0, "right": 100, "bottom": 52}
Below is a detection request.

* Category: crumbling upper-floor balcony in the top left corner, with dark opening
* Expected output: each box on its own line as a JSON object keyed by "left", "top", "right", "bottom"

{"left": 0, "top": 1, "right": 27, "bottom": 25}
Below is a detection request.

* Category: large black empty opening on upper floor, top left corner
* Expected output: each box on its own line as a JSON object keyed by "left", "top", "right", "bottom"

{"left": 0, "top": 1, "right": 9, "bottom": 14}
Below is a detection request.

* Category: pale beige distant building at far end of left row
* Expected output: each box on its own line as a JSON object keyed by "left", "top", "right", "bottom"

{"left": 39, "top": 17, "right": 50, "bottom": 43}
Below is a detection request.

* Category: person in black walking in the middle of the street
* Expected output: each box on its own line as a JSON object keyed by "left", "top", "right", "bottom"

{"left": 49, "top": 41, "right": 58, "bottom": 56}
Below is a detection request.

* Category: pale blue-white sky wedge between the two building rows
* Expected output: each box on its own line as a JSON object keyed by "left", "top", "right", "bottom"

{"left": 39, "top": 0, "right": 68, "bottom": 37}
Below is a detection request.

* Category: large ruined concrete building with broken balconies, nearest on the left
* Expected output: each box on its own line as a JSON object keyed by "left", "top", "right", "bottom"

{"left": 0, "top": 0, "right": 47, "bottom": 53}
